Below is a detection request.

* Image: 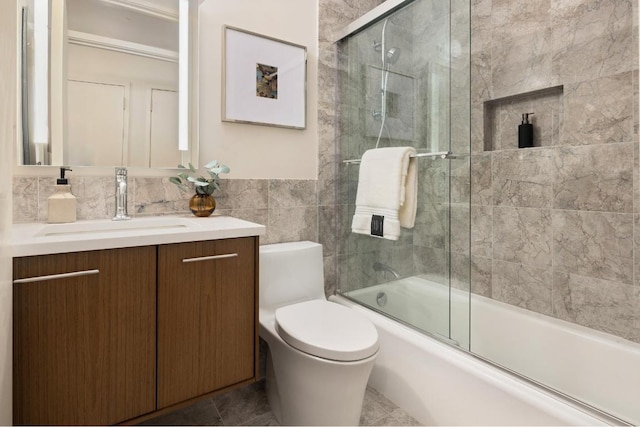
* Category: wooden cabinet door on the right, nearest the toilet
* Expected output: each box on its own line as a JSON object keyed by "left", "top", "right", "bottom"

{"left": 158, "top": 237, "right": 257, "bottom": 409}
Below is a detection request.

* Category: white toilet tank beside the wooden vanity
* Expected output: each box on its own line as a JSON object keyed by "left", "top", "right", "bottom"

{"left": 260, "top": 241, "right": 325, "bottom": 310}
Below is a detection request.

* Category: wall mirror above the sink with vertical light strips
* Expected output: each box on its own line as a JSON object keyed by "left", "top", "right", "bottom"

{"left": 19, "top": 0, "right": 197, "bottom": 168}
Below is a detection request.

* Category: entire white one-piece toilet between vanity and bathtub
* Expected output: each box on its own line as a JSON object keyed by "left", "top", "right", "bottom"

{"left": 260, "top": 242, "right": 378, "bottom": 425}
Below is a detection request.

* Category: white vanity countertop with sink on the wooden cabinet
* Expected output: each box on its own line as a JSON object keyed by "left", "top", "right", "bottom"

{"left": 10, "top": 215, "right": 266, "bottom": 257}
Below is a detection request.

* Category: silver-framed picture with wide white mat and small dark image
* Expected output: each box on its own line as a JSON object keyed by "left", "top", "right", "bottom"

{"left": 222, "top": 25, "right": 307, "bottom": 129}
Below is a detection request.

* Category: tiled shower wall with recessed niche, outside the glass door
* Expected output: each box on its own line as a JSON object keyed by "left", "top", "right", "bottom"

{"left": 471, "top": 0, "right": 640, "bottom": 342}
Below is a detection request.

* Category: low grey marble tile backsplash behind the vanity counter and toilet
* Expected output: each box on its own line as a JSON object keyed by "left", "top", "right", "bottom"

{"left": 13, "top": 176, "right": 318, "bottom": 244}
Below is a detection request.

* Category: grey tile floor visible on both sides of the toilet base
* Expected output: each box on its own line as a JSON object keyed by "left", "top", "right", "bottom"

{"left": 141, "top": 380, "right": 420, "bottom": 426}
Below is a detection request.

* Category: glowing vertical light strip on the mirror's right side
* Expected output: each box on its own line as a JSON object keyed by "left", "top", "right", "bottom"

{"left": 178, "top": 0, "right": 189, "bottom": 151}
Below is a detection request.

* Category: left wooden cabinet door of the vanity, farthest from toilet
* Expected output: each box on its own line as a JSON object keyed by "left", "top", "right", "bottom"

{"left": 13, "top": 246, "right": 156, "bottom": 425}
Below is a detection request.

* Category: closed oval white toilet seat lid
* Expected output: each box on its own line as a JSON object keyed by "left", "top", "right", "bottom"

{"left": 275, "top": 300, "right": 378, "bottom": 362}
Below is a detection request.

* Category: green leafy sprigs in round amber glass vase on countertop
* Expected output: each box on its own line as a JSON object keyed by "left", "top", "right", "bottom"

{"left": 169, "top": 160, "right": 231, "bottom": 216}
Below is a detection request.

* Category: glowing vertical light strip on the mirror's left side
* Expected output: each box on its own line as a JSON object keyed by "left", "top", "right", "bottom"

{"left": 33, "top": 0, "right": 49, "bottom": 147}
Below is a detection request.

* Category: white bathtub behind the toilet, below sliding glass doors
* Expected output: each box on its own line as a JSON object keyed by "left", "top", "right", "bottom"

{"left": 331, "top": 277, "right": 640, "bottom": 425}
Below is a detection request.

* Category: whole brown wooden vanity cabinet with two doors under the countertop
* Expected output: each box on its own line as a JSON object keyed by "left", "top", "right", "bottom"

{"left": 13, "top": 236, "right": 258, "bottom": 425}
